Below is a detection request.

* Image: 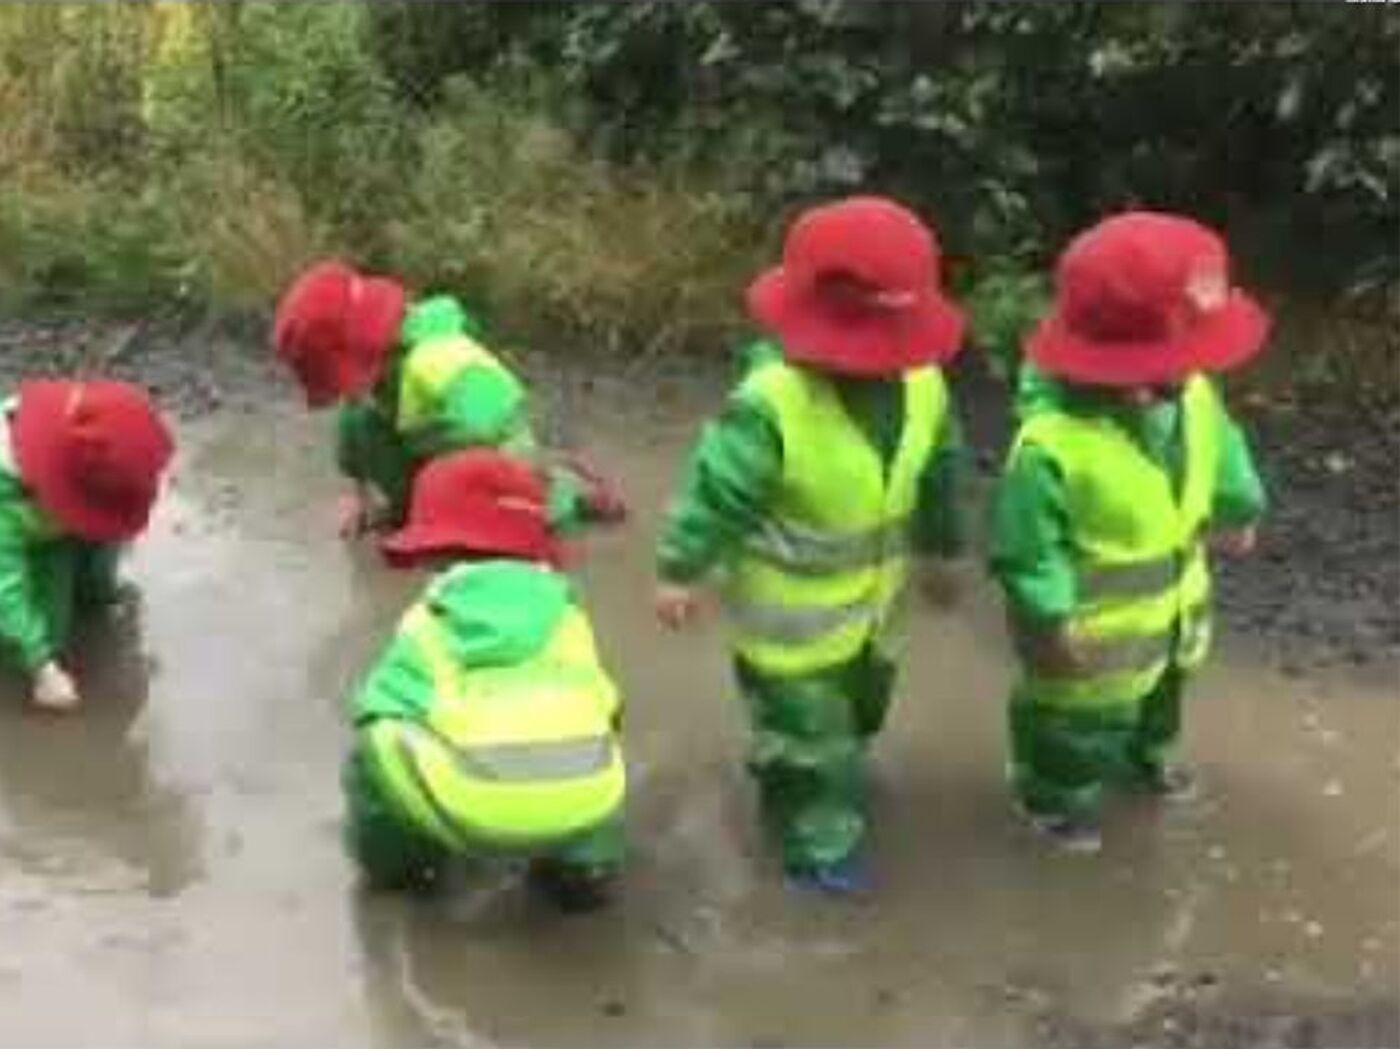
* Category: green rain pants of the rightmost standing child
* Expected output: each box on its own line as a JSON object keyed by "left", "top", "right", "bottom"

{"left": 1009, "top": 667, "right": 1184, "bottom": 819}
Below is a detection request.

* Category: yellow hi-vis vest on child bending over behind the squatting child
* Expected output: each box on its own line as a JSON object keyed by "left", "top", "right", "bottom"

{"left": 396, "top": 335, "right": 536, "bottom": 458}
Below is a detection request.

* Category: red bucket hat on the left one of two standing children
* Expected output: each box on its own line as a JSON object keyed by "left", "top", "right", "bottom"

{"left": 748, "top": 196, "right": 963, "bottom": 375}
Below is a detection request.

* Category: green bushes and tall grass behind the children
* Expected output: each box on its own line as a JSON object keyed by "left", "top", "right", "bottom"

{"left": 0, "top": 0, "right": 1400, "bottom": 395}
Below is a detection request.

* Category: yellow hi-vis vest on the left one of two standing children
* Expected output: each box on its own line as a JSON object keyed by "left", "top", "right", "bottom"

{"left": 725, "top": 360, "right": 948, "bottom": 675}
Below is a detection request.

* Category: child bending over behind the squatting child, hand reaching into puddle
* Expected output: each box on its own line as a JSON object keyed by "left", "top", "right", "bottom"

{"left": 273, "top": 262, "right": 624, "bottom": 535}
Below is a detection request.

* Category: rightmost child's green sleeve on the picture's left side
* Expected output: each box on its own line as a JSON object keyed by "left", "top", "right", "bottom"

{"left": 988, "top": 445, "right": 1075, "bottom": 623}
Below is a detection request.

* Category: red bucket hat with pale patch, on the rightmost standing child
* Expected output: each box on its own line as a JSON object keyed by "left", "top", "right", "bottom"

{"left": 1026, "top": 211, "right": 1268, "bottom": 387}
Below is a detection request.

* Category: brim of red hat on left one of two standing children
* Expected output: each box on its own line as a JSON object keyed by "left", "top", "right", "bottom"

{"left": 748, "top": 266, "right": 966, "bottom": 377}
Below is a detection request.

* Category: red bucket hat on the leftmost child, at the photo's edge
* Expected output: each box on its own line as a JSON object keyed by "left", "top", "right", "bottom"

{"left": 10, "top": 381, "right": 175, "bottom": 542}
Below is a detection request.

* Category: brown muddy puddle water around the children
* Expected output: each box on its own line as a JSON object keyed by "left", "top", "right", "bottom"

{"left": 0, "top": 397, "right": 1400, "bottom": 1046}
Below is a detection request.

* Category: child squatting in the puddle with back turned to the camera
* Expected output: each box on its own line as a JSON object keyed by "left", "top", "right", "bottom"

{"left": 344, "top": 450, "right": 624, "bottom": 910}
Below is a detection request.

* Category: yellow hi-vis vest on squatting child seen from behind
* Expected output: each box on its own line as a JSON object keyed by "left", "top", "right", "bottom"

{"left": 361, "top": 588, "right": 626, "bottom": 852}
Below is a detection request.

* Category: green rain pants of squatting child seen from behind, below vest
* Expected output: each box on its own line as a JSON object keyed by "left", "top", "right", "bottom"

{"left": 340, "top": 742, "right": 626, "bottom": 888}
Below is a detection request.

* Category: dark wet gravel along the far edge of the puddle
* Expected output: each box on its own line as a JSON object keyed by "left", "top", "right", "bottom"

{"left": 0, "top": 315, "right": 1400, "bottom": 675}
